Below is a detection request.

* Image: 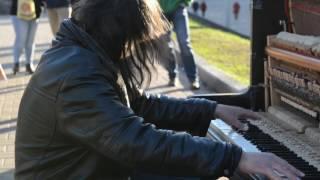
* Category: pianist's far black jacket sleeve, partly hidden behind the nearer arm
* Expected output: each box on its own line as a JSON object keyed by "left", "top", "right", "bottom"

{"left": 131, "top": 90, "right": 216, "bottom": 136}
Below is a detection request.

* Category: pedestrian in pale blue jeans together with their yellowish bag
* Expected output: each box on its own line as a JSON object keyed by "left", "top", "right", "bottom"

{"left": 10, "top": 0, "right": 42, "bottom": 75}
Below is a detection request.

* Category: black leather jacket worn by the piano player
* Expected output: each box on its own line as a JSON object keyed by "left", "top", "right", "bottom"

{"left": 15, "top": 20, "right": 241, "bottom": 180}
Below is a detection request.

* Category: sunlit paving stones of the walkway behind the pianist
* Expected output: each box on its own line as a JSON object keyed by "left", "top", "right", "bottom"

{"left": 0, "top": 16, "right": 214, "bottom": 180}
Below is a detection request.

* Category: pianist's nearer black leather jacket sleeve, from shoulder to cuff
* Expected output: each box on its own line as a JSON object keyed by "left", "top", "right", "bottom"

{"left": 56, "top": 70, "right": 241, "bottom": 177}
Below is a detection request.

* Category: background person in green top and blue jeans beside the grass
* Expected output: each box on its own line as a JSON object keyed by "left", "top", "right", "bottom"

{"left": 159, "top": 0, "right": 200, "bottom": 89}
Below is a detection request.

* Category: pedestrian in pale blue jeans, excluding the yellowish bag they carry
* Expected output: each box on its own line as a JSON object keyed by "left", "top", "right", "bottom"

{"left": 10, "top": 0, "right": 42, "bottom": 75}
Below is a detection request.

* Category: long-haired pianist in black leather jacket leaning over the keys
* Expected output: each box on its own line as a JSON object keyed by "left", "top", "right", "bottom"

{"left": 15, "top": 0, "right": 301, "bottom": 180}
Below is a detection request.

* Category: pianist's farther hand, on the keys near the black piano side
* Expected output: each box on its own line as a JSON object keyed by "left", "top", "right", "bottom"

{"left": 215, "top": 104, "right": 260, "bottom": 130}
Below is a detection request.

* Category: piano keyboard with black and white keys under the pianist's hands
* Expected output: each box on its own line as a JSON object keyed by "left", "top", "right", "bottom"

{"left": 208, "top": 120, "right": 320, "bottom": 180}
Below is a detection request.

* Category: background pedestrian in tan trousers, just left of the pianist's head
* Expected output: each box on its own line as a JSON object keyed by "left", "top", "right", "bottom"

{"left": 45, "top": 0, "right": 71, "bottom": 35}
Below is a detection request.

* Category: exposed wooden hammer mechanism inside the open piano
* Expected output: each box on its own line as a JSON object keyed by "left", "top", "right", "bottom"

{"left": 265, "top": 32, "right": 320, "bottom": 131}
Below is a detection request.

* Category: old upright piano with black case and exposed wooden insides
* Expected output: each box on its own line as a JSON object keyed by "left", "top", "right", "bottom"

{"left": 190, "top": 0, "right": 320, "bottom": 179}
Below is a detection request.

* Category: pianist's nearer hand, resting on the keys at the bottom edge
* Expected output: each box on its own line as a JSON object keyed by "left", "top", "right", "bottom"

{"left": 238, "top": 152, "right": 304, "bottom": 180}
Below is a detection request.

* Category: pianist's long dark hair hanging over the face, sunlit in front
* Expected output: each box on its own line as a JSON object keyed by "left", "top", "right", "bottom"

{"left": 72, "top": 0, "right": 168, "bottom": 95}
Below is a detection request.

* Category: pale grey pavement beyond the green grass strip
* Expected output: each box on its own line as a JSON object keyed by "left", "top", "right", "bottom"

{"left": 190, "top": 0, "right": 251, "bottom": 37}
